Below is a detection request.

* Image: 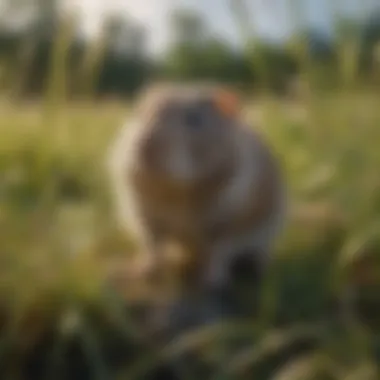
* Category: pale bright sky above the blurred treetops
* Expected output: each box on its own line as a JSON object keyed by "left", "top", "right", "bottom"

{"left": 68, "top": 0, "right": 376, "bottom": 53}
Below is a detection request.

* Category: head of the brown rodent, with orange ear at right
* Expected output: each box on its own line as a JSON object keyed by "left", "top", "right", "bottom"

{"left": 132, "top": 85, "right": 242, "bottom": 183}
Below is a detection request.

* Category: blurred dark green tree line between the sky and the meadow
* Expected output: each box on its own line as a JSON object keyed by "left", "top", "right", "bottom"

{"left": 0, "top": 0, "right": 380, "bottom": 97}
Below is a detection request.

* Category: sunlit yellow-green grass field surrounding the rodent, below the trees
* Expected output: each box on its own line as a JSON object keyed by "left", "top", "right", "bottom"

{"left": 0, "top": 88, "right": 380, "bottom": 380}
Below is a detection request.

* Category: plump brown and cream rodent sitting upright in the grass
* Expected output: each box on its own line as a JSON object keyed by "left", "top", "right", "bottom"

{"left": 109, "top": 84, "right": 286, "bottom": 286}
